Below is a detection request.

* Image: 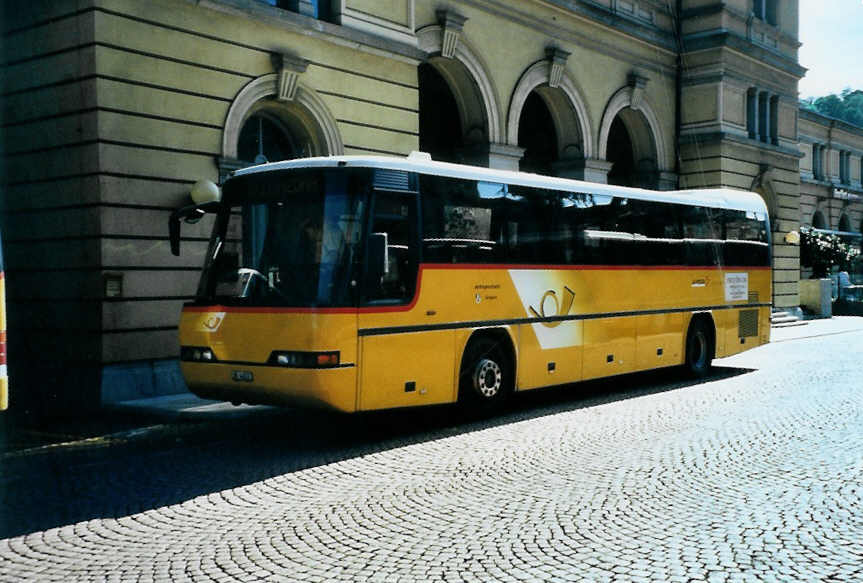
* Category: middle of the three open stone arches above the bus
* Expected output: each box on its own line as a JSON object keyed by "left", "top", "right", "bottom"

{"left": 506, "top": 60, "right": 594, "bottom": 158}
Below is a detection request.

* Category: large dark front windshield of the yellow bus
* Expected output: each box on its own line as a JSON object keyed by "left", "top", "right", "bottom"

{"left": 198, "top": 170, "right": 367, "bottom": 307}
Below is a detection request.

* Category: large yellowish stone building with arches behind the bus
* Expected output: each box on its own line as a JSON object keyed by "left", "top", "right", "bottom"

{"left": 0, "top": 0, "right": 808, "bottom": 410}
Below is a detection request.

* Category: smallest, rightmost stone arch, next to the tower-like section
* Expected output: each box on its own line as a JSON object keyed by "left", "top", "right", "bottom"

{"left": 596, "top": 86, "right": 670, "bottom": 171}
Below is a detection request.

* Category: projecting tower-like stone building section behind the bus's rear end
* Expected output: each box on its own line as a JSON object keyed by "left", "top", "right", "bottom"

{"left": 680, "top": 0, "right": 805, "bottom": 309}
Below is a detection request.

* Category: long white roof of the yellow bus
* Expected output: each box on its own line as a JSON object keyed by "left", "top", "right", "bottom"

{"left": 234, "top": 155, "right": 767, "bottom": 214}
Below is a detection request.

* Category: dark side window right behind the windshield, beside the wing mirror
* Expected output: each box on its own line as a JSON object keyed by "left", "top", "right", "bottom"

{"left": 364, "top": 192, "right": 418, "bottom": 304}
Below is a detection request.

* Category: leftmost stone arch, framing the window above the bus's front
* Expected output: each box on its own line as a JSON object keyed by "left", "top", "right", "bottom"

{"left": 222, "top": 73, "right": 345, "bottom": 159}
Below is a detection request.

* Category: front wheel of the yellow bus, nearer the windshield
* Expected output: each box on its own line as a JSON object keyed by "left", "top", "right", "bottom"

{"left": 458, "top": 335, "right": 515, "bottom": 411}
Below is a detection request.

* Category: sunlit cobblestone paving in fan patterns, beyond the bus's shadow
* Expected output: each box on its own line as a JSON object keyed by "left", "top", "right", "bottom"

{"left": 0, "top": 321, "right": 863, "bottom": 583}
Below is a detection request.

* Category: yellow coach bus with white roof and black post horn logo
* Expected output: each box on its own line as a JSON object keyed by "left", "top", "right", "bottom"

{"left": 171, "top": 154, "right": 771, "bottom": 412}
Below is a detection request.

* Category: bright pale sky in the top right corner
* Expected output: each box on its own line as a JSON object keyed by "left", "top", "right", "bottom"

{"left": 798, "top": 0, "right": 863, "bottom": 99}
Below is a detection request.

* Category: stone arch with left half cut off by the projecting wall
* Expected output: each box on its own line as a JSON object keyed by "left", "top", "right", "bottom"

{"left": 417, "top": 24, "right": 502, "bottom": 144}
